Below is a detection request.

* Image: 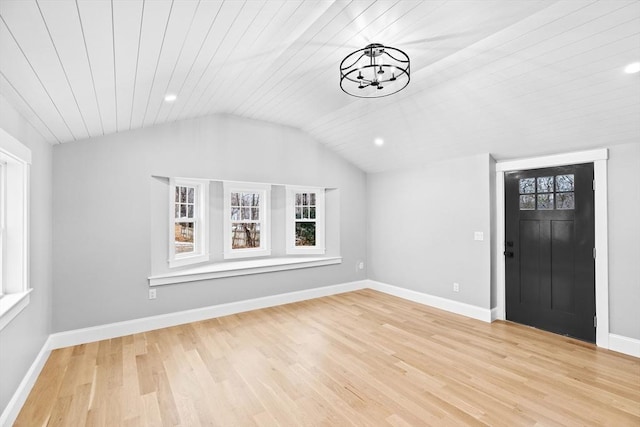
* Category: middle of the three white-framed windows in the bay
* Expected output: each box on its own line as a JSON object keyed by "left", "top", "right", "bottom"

{"left": 223, "top": 182, "right": 271, "bottom": 259}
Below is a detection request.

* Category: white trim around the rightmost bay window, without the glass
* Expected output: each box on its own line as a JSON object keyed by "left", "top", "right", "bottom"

{"left": 286, "top": 185, "right": 326, "bottom": 255}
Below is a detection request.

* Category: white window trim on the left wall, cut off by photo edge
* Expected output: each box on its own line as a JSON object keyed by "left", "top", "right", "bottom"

{"left": 0, "top": 129, "right": 31, "bottom": 330}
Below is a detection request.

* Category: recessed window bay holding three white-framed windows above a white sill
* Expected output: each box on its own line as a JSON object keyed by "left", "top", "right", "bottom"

{"left": 149, "top": 176, "right": 342, "bottom": 286}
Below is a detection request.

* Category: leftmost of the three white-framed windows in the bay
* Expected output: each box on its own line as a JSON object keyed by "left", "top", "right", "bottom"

{"left": 169, "top": 178, "right": 209, "bottom": 267}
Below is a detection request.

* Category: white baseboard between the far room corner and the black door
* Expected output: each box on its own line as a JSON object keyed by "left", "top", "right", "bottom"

{"left": 368, "top": 280, "right": 492, "bottom": 322}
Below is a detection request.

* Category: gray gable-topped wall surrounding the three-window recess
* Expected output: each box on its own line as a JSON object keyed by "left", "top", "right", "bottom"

{"left": 53, "top": 116, "right": 366, "bottom": 332}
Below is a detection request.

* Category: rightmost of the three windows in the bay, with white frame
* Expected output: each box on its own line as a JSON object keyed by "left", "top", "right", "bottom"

{"left": 286, "top": 187, "right": 325, "bottom": 254}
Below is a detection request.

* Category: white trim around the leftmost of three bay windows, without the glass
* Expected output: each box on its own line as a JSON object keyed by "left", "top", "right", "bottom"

{"left": 168, "top": 178, "right": 209, "bottom": 268}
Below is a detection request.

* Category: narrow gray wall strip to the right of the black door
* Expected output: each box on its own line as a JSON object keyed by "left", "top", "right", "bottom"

{"left": 607, "top": 143, "right": 640, "bottom": 340}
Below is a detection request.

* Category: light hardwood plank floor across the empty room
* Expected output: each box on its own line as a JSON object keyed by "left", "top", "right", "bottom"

{"left": 16, "top": 290, "right": 640, "bottom": 426}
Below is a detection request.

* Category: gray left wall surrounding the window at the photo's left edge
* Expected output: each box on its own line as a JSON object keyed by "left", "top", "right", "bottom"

{"left": 0, "top": 96, "right": 52, "bottom": 413}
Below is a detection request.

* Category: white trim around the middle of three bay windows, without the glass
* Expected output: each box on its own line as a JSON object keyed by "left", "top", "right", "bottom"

{"left": 222, "top": 181, "right": 271, "bottom": 259}
